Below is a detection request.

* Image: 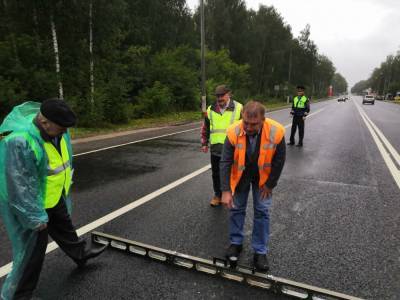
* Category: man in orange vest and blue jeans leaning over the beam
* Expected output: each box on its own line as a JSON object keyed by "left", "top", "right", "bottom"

{"left": 220, "top": 101, "right": 286, "bottom": 271}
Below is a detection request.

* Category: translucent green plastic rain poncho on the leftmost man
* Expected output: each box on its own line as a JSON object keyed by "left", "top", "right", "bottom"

{"left": 0, "top": 102, "right": 72, "bottom": 300}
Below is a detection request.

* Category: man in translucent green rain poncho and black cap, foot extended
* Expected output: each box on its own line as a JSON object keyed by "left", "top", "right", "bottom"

{"left": 0, "top": 99, "right": 105, "bottom": 300}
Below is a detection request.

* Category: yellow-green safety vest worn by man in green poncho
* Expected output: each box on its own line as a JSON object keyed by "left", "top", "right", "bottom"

{"left": 43, "top": 137, "right": 72, "bottom": 208}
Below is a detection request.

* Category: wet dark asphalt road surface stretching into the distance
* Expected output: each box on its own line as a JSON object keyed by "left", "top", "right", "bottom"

{"left": 0, "top": 97, "right": 400, "bottom": 299}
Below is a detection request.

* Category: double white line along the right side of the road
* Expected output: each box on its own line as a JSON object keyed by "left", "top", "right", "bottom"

{"left": 354, "top": 102, "right": 400, "bottom": 189}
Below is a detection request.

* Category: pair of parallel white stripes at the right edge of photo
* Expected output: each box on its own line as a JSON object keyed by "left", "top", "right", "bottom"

{"left": 353, "top": 101, "right": 400, "bottom": 189}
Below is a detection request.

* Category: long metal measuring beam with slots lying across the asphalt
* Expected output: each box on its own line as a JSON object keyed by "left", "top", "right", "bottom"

{"left": 92, "top": 231, "right": 361, "bottom": 300}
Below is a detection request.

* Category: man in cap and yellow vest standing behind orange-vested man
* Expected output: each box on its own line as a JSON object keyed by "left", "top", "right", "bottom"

{"left": 201, "top": 85, "right": 242, "bottom": 206}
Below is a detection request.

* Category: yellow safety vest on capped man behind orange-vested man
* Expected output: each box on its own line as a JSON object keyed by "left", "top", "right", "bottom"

{"left": 207, "top": 101, "right": 242, "bottom": 145}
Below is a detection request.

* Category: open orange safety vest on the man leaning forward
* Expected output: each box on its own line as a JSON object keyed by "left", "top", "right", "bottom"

{"left": 227, "top": 119, "right": 285, "bottom": 193}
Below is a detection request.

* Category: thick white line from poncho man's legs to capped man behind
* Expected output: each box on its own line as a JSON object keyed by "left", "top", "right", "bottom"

{"left": 0, "top": 164, "right": 211, "bottom": 278}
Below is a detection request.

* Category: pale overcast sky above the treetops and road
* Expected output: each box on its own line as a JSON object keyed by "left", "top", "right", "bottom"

{"left": 187, "top": 0, "right": 400, "bottom": 87}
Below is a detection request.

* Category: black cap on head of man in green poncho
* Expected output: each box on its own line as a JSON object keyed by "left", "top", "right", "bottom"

{"left": 40, "top": 98, "right": 76, "bottom": 127}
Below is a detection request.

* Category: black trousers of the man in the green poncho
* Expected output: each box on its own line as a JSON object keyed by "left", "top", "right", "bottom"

{"left": 15, "top": 198, "right": 86, "bottom": 299}
